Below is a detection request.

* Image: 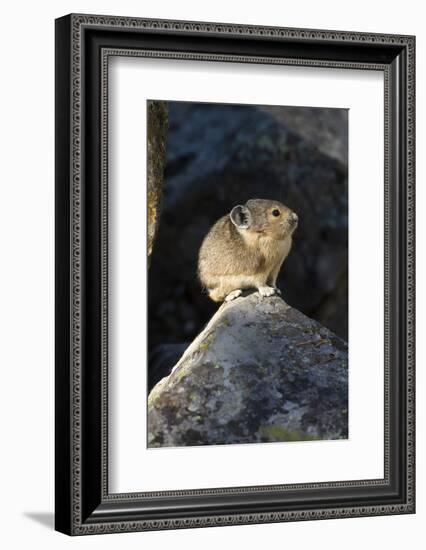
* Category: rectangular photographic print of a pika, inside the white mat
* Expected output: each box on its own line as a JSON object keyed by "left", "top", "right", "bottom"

{"left": 147, "top": 101, "right": 348, "bottom": 448}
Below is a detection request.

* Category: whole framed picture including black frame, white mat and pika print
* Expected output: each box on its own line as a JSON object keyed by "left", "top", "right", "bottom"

{"left": 55, "top": 14, "right": 415, "bottom": 535}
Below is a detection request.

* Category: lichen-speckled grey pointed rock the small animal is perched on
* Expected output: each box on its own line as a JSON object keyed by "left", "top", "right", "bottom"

{"left": 148, "top": 292, "right": 348, "bottom": 447}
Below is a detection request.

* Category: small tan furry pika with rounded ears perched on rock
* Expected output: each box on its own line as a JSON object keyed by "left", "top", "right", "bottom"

{"left": 198, "top": 199, "right": 298, "bottom": 302}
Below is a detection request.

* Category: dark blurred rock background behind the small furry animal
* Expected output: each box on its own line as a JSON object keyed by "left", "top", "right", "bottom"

{"left": 148, "top": 102, "right": 348, "bottom": 387}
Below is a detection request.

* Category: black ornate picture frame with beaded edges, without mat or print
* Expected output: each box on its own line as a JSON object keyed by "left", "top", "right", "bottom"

{"left": 55, "top": 14, "right": 415, "bottom": 535}
